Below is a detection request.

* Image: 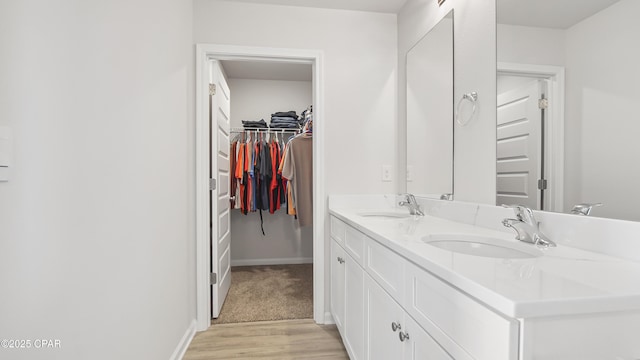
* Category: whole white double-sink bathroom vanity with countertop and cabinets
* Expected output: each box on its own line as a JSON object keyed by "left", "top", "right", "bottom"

{"left": 330, "top": 198, "right": 640, "bottom": 360}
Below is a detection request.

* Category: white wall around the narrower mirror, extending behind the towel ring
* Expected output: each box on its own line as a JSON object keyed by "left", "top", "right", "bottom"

{"left": 398, "top": 0, "right": 496, "bottom": 204}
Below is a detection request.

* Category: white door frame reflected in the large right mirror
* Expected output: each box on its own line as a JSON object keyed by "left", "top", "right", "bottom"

{"left": 497, "top": 62, "right": 565, "bottom": 212}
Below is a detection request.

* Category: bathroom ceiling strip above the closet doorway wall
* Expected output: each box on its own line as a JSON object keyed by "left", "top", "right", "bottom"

{"left": 212, "top": 0, "right": 408, "bottom": 14}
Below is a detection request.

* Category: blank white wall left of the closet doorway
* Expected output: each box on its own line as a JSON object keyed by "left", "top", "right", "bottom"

{"left": 0, "top": 0, "right": 195, "bottom": 360}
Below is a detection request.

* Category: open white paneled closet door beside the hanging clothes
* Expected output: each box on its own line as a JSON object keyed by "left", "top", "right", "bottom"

{"left": 209, "top": 61, "right": 231, "bottom": 318}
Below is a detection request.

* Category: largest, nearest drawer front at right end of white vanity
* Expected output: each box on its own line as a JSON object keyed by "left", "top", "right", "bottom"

{"left": 405, "top": 262, "right": 518, "bottom": 360}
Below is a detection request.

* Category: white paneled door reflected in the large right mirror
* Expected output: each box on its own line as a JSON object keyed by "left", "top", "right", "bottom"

{"left": 496, "top": 76, "right": 547, "bottom": 210}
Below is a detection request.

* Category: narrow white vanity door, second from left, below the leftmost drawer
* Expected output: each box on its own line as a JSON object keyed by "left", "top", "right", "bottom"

{"left": 344, "top": 253, "right": 364, "bottom": 360}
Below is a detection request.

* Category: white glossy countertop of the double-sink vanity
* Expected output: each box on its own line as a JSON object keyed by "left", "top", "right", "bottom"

{"left": 329, "top": 208, "right": 640, "bottom": 318}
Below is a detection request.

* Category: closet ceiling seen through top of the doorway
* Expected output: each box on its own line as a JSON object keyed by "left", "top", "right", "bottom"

{"left": 221, "top": 60, "right": 312, "bottom": 81}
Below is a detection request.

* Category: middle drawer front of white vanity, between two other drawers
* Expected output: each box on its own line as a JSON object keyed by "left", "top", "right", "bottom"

{"left": 365, "top": 239, "right": 407, "bottom": 304}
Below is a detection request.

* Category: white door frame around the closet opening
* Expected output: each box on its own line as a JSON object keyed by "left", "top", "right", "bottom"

{"left": 195, "top": 44, "right": 326, "bottom": 331}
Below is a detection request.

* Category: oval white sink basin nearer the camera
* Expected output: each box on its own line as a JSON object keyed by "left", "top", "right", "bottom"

{"left": 421, "top": 234, "right": 543, "bottom": 259}
